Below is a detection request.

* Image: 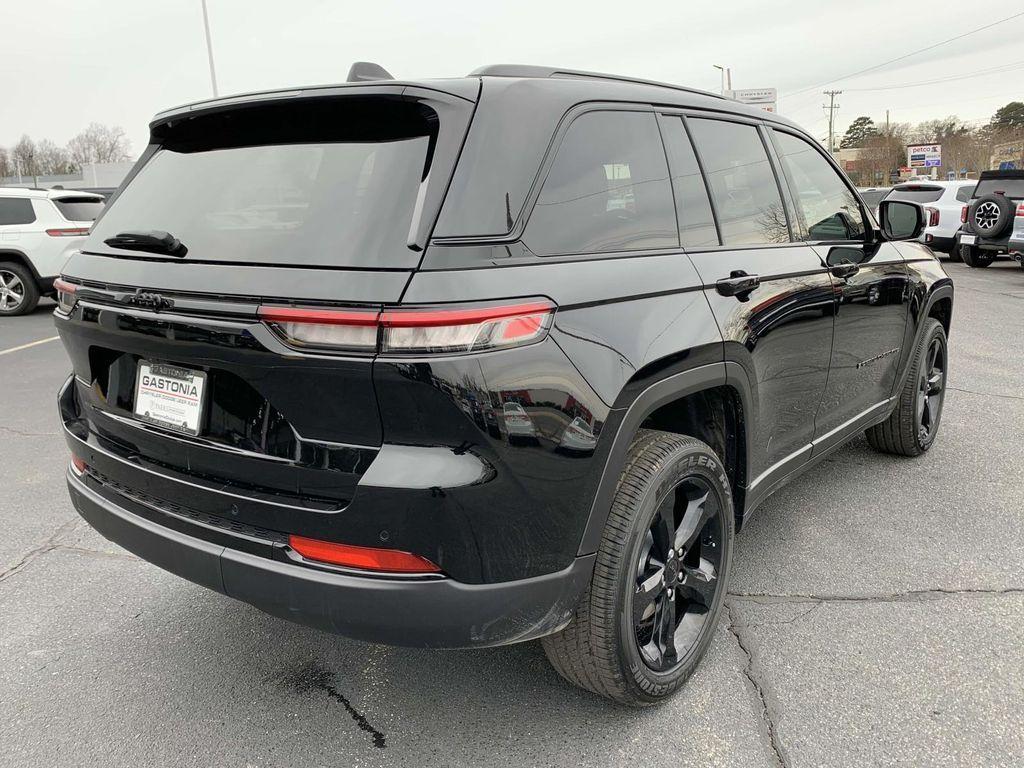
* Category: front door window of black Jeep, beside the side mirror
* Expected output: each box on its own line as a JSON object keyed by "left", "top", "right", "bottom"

{"left": 774, "top": 131, "right": 864, "bottom": 240}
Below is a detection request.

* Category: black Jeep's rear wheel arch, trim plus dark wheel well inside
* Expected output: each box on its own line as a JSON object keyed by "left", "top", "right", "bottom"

{"left": 579, "top": 361, "right": 752, "bottom": 555}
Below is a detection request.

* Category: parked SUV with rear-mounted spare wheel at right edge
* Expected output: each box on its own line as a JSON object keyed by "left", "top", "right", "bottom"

{"left": 956, "top": 170, "right": 1024, "bottom": 267}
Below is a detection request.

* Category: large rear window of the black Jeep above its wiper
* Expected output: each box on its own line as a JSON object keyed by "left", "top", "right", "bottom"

{"left": 86, "top": 98, "right": 436, "bottom": 268}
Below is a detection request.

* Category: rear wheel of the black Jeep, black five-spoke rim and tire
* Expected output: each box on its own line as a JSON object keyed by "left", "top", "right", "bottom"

{"left": 542, "top": 430, "right": 734, "bottom": 707}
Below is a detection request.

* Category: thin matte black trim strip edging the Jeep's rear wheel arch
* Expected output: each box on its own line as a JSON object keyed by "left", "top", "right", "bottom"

{"left": 579, "top": 361, "right": 752, "bottom": 555}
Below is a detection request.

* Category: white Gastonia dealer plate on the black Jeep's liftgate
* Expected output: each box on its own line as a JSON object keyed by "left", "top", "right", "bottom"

{"left": 135, "top": 360, "right": 206, "bottom": 435}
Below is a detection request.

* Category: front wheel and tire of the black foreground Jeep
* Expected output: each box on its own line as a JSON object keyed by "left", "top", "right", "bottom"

{"left": 864, "top": 317, "right": 949, "bottom": 456}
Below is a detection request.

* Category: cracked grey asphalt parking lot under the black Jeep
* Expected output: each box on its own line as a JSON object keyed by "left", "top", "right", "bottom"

{"left": 0, "top": 262, "right": 1024, "bottom": 766}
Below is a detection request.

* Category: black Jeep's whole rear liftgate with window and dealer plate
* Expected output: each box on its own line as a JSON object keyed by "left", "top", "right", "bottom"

{"left": 56, "top": 85, "right": 473, "bottom": 536}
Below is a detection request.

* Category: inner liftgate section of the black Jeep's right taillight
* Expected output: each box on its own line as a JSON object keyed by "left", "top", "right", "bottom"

{"left": 259, "top": 306, "right": 380, "bottom": 352}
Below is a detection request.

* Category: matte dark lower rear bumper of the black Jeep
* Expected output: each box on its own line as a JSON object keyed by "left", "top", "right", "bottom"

{"left": 68, "top": 471, "right": 595, "bottom": 648}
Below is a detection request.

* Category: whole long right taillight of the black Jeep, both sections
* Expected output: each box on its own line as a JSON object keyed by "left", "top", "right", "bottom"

{"left": 259, "top": 300, "right": 555, "bottom": 354}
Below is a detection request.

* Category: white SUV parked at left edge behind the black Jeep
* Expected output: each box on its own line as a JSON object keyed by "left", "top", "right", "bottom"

{"left": 0, "top": 186, "right": 103, "bottom": 316}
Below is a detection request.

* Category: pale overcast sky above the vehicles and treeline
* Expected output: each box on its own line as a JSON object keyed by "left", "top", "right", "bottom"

{"left": 6, "top": 0, "right": 1024, "bottom": 156}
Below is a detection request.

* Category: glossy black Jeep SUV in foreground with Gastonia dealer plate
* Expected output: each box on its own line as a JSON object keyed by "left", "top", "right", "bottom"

{"left": 56, "top": 67, "right": 952, "bottom": 705}
